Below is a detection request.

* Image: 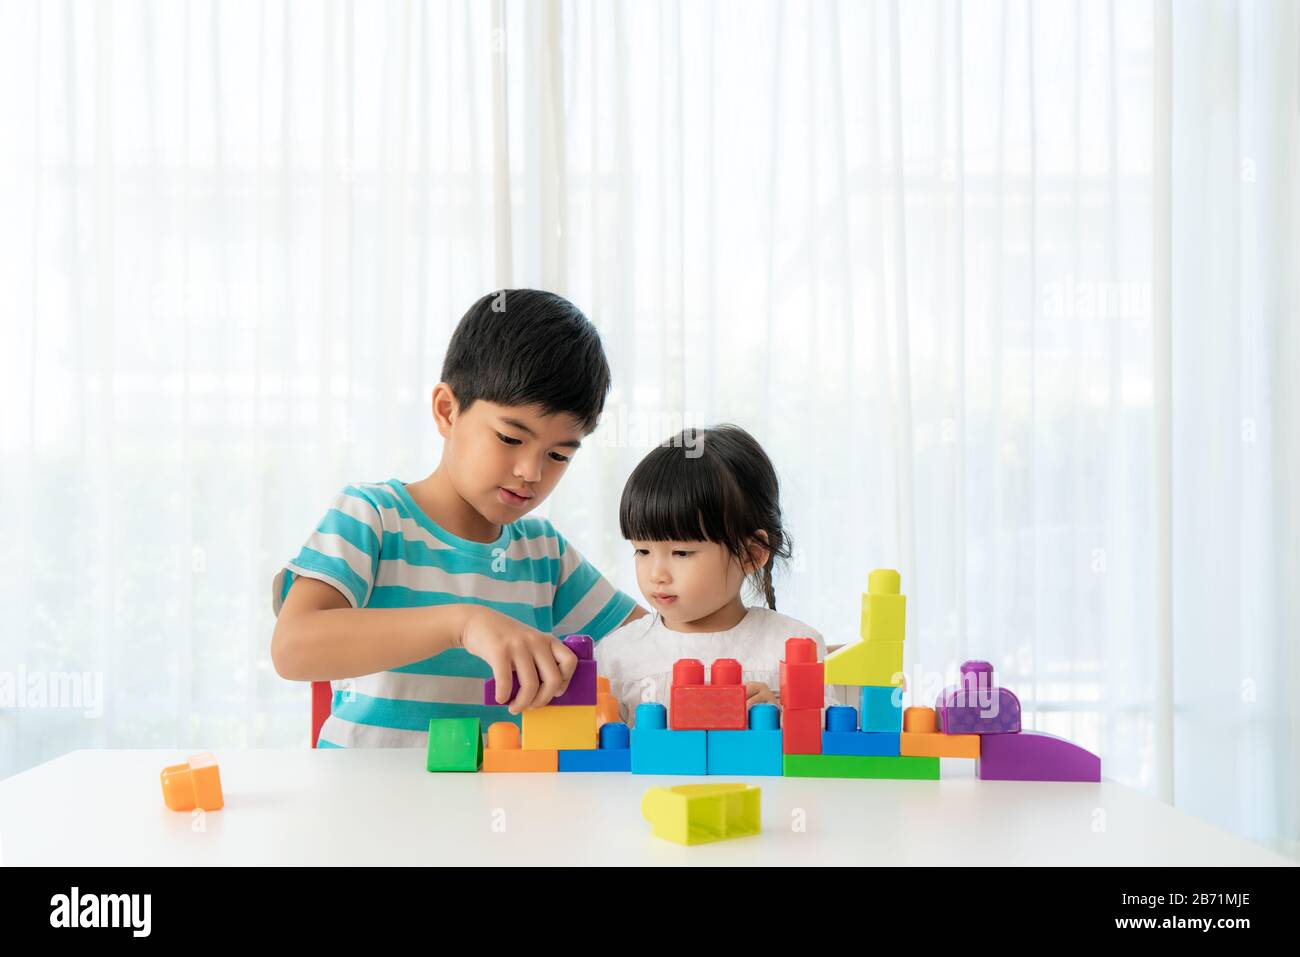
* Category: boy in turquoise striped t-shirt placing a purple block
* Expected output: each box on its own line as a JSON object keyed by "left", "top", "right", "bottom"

{"left": 270, "top": 289, "right": 647, "bottom": 748}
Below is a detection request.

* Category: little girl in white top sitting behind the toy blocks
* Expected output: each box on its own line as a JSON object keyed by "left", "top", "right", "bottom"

{"left": 595, "top": 425, "right": 836, "bottom": 724}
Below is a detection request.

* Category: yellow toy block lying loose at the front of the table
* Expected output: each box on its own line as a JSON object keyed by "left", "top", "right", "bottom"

{"left": 638, "top": 785, "right": 763, "bottom": 844}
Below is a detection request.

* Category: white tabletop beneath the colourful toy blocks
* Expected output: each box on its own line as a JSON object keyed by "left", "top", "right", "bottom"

{"left": 0, "top": 748, "right": 1295, "bottom": 866}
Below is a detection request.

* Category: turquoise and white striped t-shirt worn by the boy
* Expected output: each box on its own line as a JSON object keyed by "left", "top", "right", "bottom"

{"left": 272, "top": 479, "right": 636, "bottom": 748}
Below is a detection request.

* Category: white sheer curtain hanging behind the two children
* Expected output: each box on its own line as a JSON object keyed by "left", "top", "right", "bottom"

{"left": 0, "top": 0, "right": 1300, "bottom": 858}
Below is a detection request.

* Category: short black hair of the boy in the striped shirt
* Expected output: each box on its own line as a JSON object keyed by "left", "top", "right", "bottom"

{"left": 442, "top": 289, "right": 610, "bottom": 434}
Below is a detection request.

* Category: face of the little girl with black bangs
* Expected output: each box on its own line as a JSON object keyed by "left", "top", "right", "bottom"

{"left": 632, "top": 541, "right": 745, "bottom": 625}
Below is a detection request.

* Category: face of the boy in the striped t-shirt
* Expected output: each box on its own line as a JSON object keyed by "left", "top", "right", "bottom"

{"left": 434, "top": 385, "right": 582, "bottom": 525}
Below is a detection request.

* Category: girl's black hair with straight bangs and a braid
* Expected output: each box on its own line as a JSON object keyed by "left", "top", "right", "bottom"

{"left": 619, "top": 424, "right": 790, "bottom": 610}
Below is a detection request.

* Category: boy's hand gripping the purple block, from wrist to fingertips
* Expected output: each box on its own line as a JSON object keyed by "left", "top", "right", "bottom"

{"left": 460, "top": 609, "right": 577, "bottom": 714}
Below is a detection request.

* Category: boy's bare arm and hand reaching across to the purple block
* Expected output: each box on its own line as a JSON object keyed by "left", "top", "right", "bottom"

{"left": 270, "top": 577, "right": 577, "bottom": 714}
